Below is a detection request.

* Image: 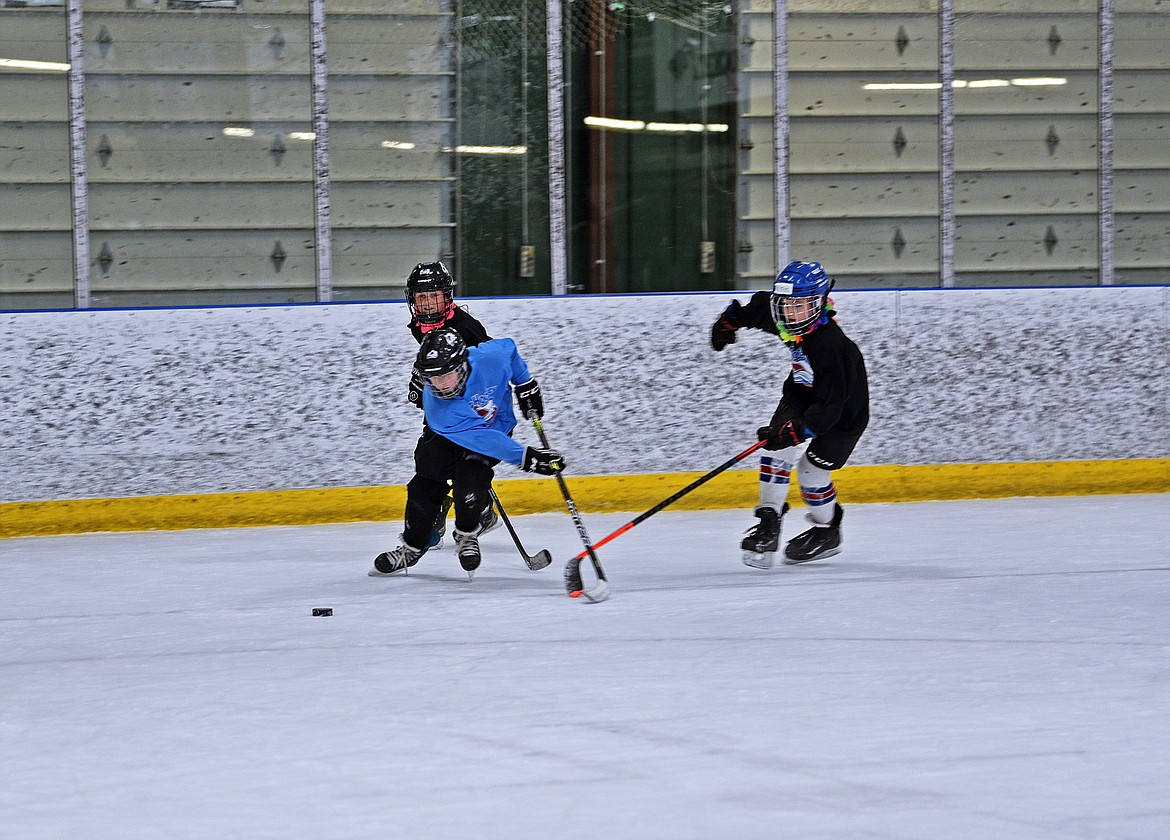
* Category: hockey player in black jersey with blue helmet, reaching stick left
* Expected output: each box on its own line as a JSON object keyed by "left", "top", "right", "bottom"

{"left": 711, "top": 261, "right": 869, "bottom": 569}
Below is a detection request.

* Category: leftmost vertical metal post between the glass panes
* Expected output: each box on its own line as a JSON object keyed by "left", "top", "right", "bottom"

{"left": 66, "top": 0, "right": 89, "bottom": 309}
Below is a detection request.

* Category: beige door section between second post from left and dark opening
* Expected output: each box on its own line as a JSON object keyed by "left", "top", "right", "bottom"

{"left": 325, "top": 0, "right": 463, "bottom": 301}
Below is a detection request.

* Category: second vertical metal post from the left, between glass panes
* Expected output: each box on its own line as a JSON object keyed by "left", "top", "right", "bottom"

{"left": 309, "top": 0, "right": 333, "bottom": 303}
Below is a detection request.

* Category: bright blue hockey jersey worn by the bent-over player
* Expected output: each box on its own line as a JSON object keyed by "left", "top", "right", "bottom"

{"left": 422, "top": 338, "right": 532, "bottom": 467}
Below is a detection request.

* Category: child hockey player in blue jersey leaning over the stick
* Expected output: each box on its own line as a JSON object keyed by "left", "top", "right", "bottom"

{"left": 370, "top": 328, "right": 565, "bottom": 578}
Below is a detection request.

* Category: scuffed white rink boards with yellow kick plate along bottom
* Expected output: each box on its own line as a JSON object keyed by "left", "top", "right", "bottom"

{"left": 0, "top": 287, "right": 1170, "bottom": 536}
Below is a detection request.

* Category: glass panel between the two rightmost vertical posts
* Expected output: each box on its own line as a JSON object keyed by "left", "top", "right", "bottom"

{"left": 955, "top": 0, "right": 1097, "bottom": 285}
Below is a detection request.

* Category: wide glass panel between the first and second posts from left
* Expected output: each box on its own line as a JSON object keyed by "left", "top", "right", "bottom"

{"left": 84, "top": 0, "right": 316, "bottom": 307}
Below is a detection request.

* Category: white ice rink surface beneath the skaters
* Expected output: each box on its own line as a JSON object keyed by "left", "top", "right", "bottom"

{"left": 0, "top": 495, "right": 1170, "bottom": 840}
